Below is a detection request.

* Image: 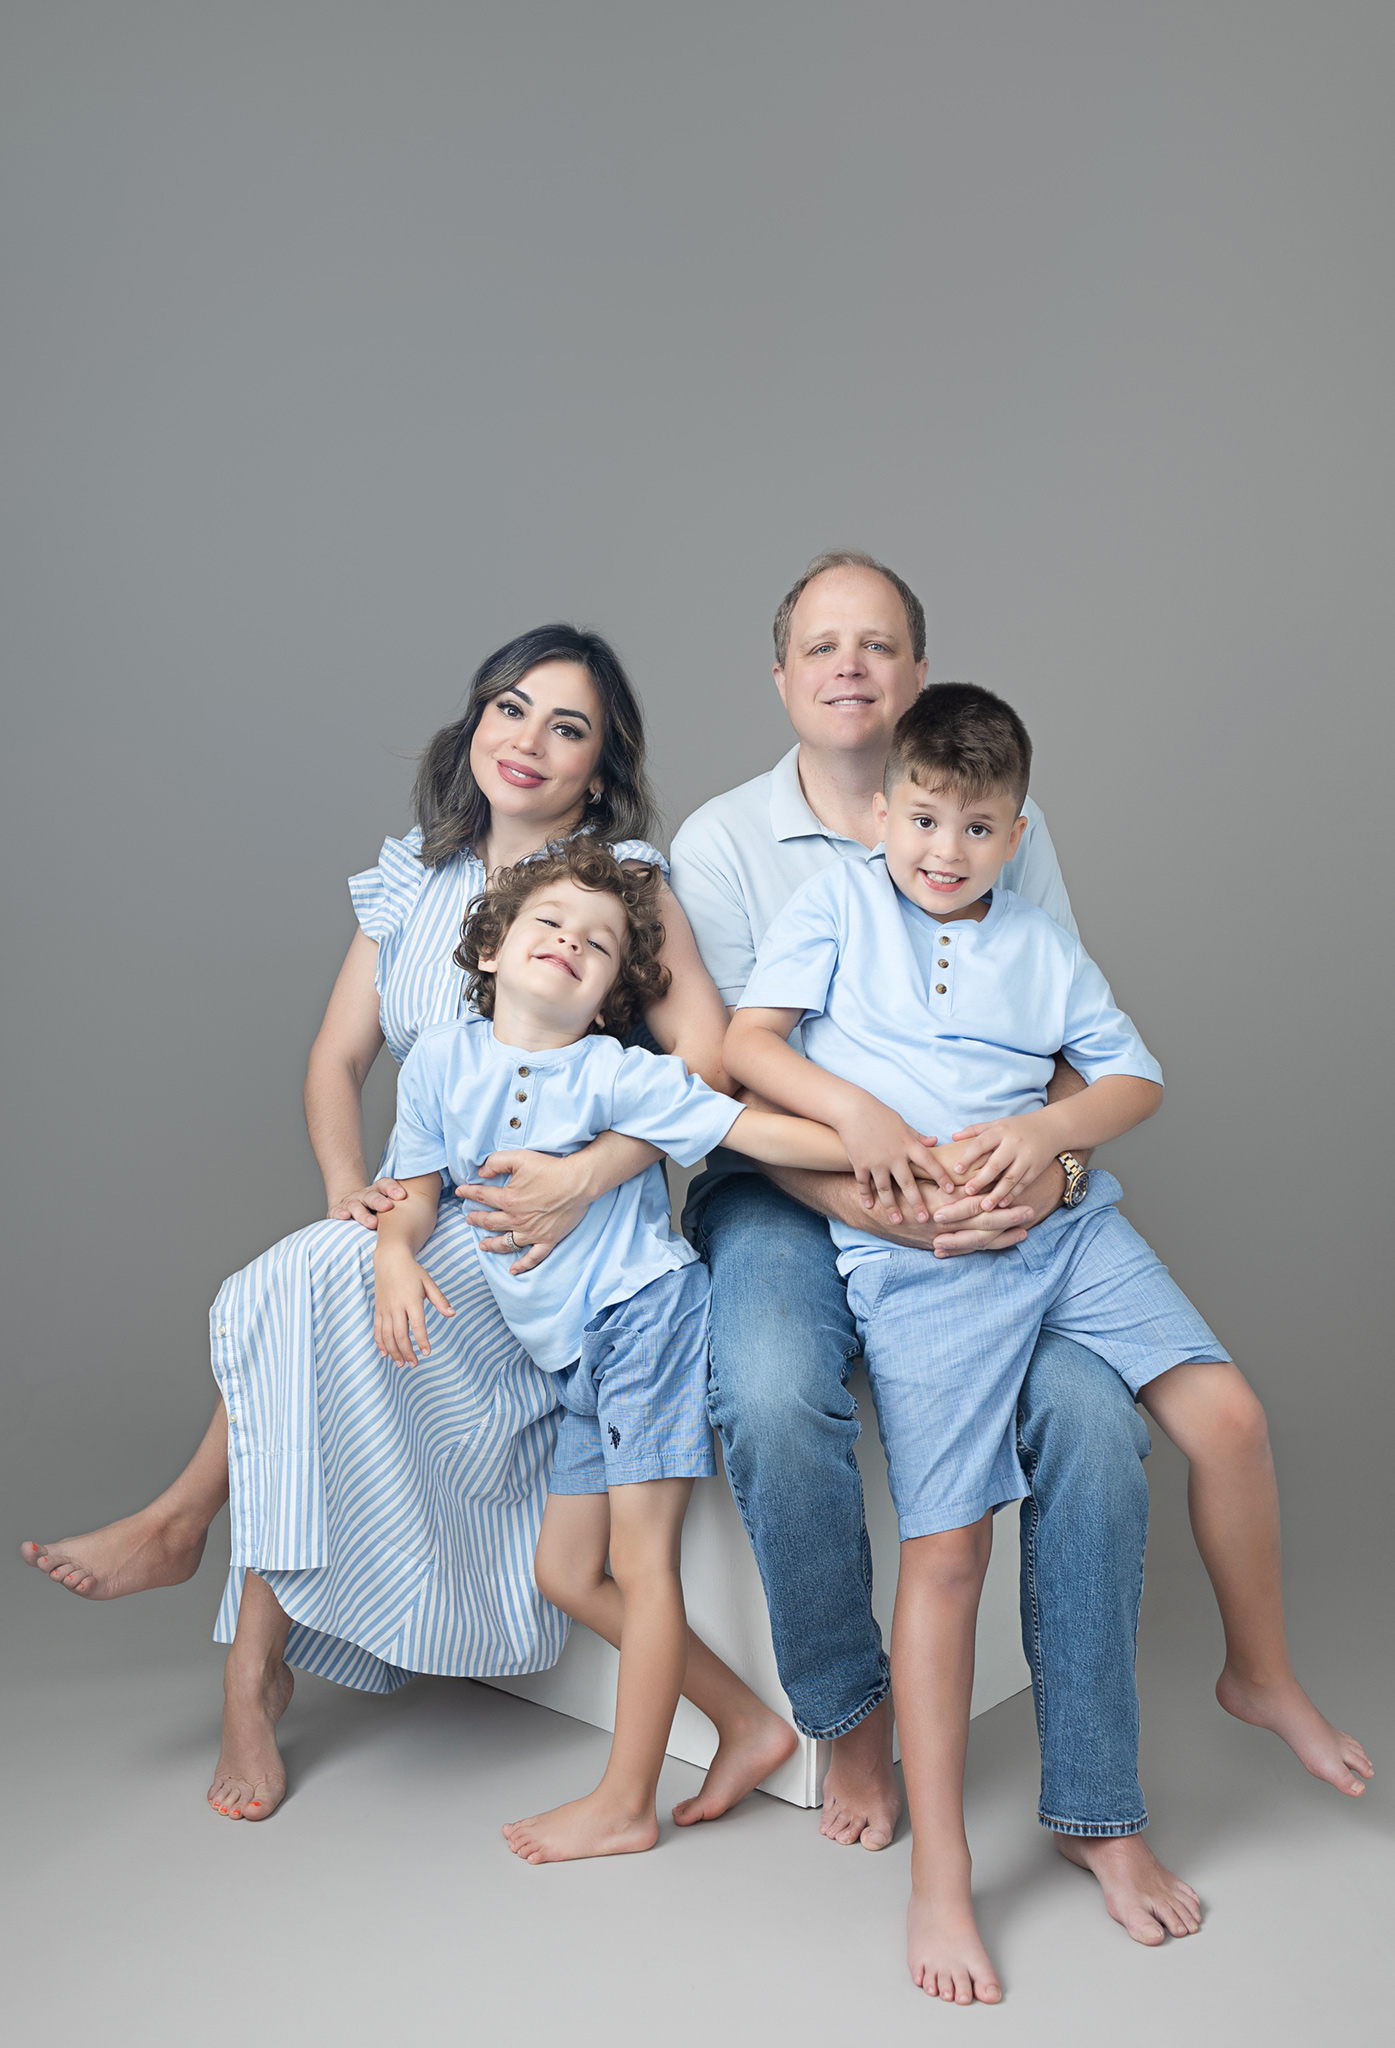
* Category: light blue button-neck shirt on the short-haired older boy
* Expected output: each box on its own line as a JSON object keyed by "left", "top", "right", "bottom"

{"left": 739, "top": 852, "right": 1161, "bottom": 1274}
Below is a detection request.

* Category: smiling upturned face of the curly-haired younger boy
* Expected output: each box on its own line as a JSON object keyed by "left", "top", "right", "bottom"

{"left": 479, "top": 879, "right": 629, "bottom": 1051}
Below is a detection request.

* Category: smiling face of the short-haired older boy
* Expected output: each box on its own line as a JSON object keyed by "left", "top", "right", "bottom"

{"left": 875, "top": 780, "right": 1026, "bottom": 924}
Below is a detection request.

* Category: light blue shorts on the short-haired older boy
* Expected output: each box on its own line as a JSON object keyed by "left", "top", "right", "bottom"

{"left": 848, "top": 1169, "right": 1229, "bottom": 1542}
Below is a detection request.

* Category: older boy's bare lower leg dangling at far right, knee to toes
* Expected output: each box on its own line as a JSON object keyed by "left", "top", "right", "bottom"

{"left": 1139, "top": 1364, "right": 1375, "bottom": 1798}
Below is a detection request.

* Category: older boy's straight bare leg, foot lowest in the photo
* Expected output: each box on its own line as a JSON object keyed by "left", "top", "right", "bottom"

{"left": 891, "top": 1516, "right": 1002, "bottom": 2005}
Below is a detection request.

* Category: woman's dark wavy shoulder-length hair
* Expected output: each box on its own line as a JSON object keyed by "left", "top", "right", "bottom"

{"left": 412, "top": 625, "right": 653, "bottom": 868}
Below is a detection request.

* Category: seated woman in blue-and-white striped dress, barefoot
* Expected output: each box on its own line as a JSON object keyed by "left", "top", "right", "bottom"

{"left": 23, "top": 625, "right": 741, "bottom": 1819}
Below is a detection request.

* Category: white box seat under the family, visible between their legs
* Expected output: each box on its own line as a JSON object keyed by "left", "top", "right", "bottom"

{"left": 485, "top": 1368, "right": 1030, "bottom": 1806}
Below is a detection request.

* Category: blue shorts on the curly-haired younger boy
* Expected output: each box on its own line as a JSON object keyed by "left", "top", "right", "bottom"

{"left": 549, "top": 1260, "right": 717, "bottom": 1493}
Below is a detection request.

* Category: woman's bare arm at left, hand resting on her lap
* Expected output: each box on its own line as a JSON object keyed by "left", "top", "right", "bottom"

{"left": 305, "top": 932, "right": 404, "bottom": 1231}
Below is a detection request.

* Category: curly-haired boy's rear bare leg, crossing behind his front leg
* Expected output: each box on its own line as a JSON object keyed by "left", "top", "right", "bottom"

{"left": 537, "top": 1493, "right": 799, "bottom": 1827}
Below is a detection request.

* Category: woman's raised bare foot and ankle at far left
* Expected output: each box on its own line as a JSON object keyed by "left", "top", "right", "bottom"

{"left": 18, "top": 1395, "right": 227, "bottom": 1599}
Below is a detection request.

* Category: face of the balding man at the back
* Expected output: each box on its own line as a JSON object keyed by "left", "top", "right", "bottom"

{"left": 774, "top": 567, "right": 926, "bottom": 756}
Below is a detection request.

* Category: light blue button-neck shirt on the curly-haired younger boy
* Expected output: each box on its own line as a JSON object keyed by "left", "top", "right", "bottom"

{"left": 393, "top": 1016, "right": 742, "bottom": 1372}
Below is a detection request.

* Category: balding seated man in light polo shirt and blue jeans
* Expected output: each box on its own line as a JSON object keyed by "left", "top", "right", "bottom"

{"left": 672, "top": 553, "right": 1200, "bottom": 1946}
